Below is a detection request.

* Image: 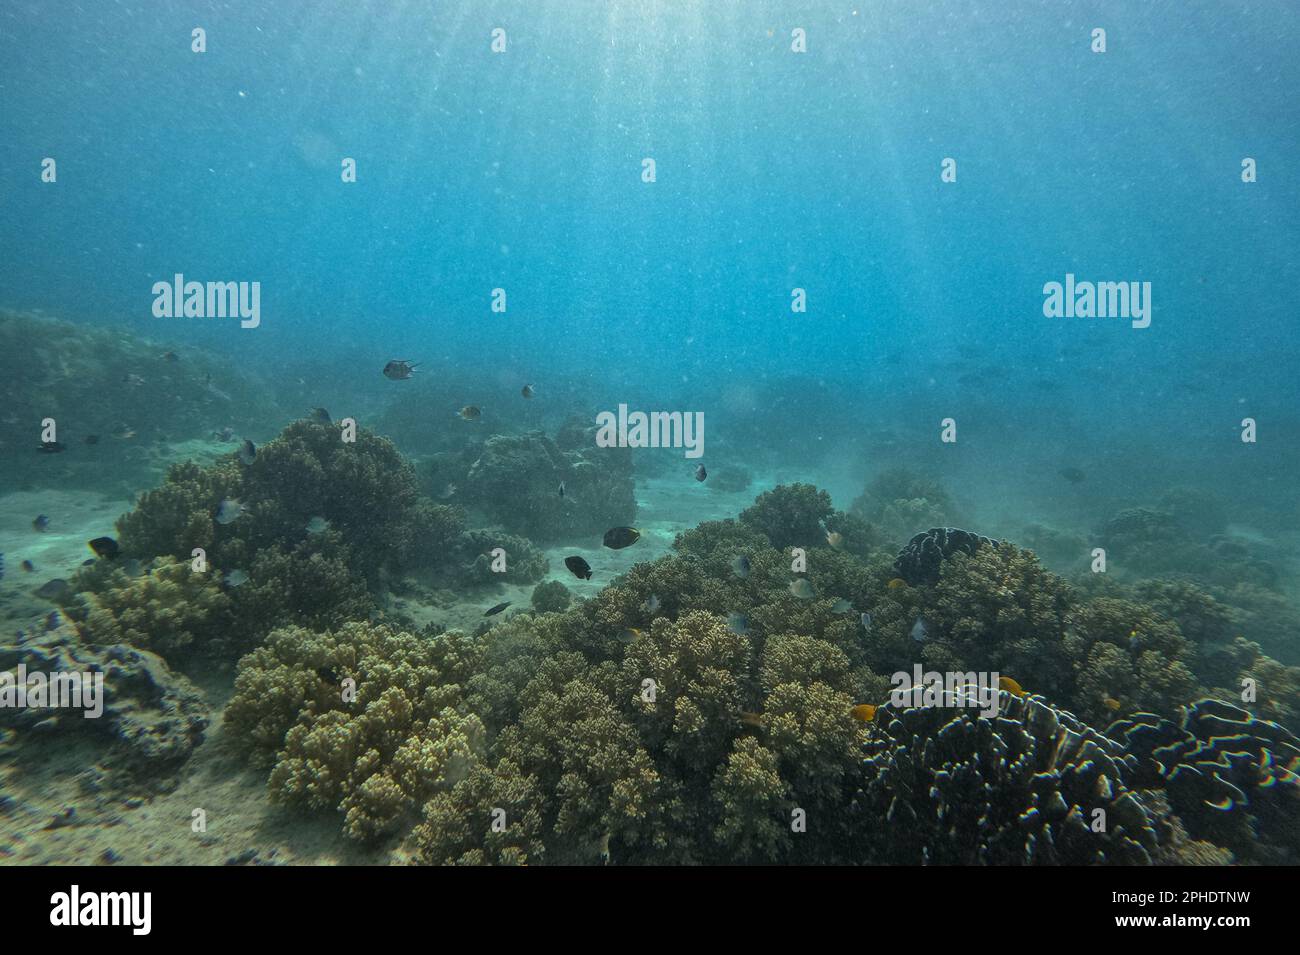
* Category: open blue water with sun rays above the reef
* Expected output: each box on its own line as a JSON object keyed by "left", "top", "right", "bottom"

{"left": 0, "top": 0, "right": 1300, "bottom": 515}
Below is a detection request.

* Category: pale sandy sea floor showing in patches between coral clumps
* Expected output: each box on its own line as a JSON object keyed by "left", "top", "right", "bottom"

{"left": 0, "top": 462, "right": 769, "bottom": 865}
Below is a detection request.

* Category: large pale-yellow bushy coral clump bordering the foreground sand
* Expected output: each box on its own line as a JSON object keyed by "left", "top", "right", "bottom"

{"left": 225, "top": 624, "right": 484, "bottom": 839}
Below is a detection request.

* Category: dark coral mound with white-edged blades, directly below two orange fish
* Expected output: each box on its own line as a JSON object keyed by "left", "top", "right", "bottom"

{"left": 853, "top": 693, "right": 1161, "bottom": 865}
